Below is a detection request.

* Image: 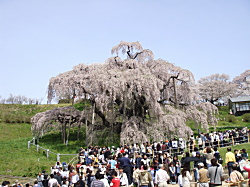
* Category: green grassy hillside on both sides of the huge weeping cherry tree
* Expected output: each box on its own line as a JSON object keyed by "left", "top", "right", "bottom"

{"left": 0, "top": 104, "right": 250, "bottom": 177}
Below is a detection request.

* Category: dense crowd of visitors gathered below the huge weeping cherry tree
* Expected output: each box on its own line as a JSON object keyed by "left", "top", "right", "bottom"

{"left": 2, "top": 128, "right": 250, "bottom": 187}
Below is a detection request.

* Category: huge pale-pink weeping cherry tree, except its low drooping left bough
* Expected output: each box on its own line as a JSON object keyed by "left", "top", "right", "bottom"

{"left": 33, "top": 41, "right": 217, "bottom": 144}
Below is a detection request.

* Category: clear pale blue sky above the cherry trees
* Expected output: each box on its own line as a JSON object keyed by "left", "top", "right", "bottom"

{"left": 0, "top": 0, "right": 250, "bottom": 103}
